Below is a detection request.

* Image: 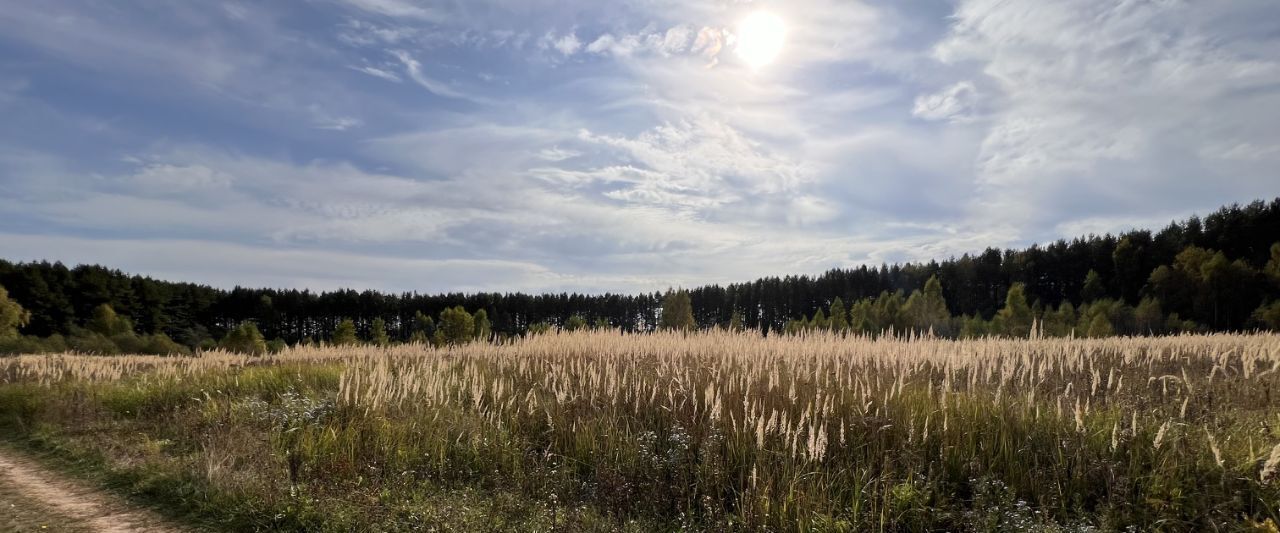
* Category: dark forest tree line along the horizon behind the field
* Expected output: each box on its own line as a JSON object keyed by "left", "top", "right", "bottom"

{"left": 0, "top": 199, "right": 1280, "bottom": 347}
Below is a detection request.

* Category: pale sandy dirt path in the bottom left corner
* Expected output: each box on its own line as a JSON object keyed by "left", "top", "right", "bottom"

{"left": 0, "top": 446, "right": 182, "bottom": 533}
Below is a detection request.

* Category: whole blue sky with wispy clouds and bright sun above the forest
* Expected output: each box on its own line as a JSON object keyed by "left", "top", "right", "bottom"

{"left": 0, "top": 0, "right": 1280, "bottom": 292}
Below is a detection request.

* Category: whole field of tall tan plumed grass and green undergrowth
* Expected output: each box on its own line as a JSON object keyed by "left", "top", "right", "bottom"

{"left": 0, "top": 332, "right": 1280, "bottom": 532}
